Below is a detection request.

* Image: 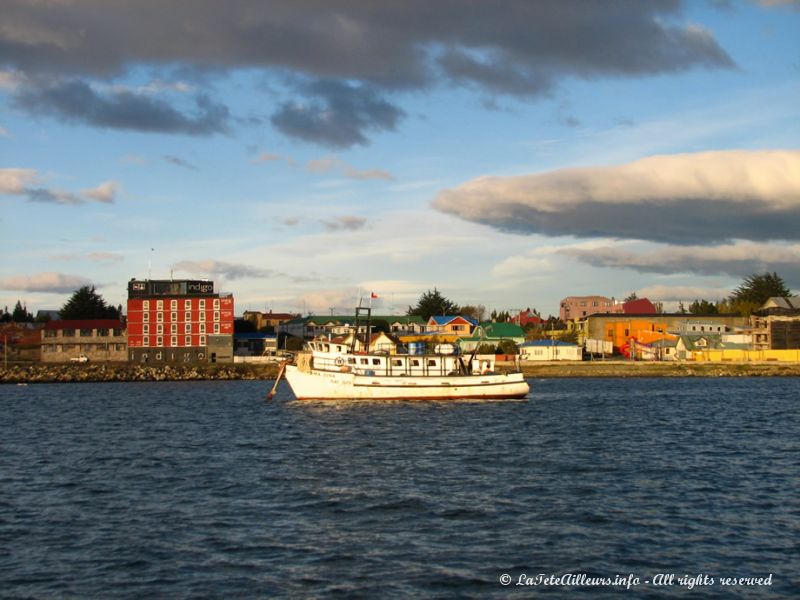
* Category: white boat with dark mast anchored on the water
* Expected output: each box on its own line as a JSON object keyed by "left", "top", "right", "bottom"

{"left": 278, "top": 311, "right": 530, "bottom": 400}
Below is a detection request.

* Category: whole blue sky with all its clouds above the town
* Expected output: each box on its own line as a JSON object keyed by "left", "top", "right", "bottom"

{"left": 0, "top": 0, "right": 800, "bottom": 315}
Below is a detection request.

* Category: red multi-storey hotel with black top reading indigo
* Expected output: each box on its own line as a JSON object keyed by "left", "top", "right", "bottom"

{"left": 128, "top": 279, "right": 233, "bottom": 364}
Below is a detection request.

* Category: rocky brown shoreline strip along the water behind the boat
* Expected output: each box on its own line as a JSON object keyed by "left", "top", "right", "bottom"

{"left": 0, "top": 361, "right": 800, "bottom": 384}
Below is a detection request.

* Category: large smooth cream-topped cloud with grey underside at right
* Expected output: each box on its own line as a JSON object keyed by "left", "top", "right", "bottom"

{"left": 433, "top": 150, "right": 800, "bottom": 245}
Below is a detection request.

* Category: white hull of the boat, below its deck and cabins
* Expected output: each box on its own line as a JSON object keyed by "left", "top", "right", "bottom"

{"left": 285, "top": 365, "right": 530, "bottom": 400}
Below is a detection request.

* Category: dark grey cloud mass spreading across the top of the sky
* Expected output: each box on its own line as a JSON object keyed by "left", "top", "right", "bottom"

{"left": 0, "top": 0, "right": 735, "bottom": 148}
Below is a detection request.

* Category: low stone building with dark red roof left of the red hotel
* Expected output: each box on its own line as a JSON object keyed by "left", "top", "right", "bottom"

{"left": 41, "top": 319, "right": 128, "bottom": 363}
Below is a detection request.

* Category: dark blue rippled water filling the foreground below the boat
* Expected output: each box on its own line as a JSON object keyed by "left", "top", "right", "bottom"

{"left": 0, "top": 378, "right": 800, "bottom": 598}
